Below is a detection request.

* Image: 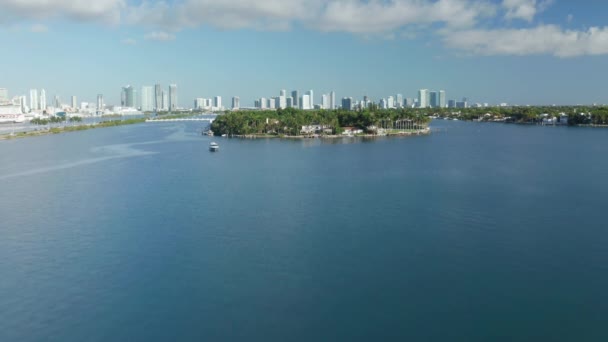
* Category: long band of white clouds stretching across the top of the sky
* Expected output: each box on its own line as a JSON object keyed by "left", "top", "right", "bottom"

{"left": 0, "top": 0, "right": 608, "bottom": 58}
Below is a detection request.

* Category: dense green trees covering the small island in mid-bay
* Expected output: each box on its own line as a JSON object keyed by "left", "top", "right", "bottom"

{"left": 211, "top": 108, "right": 430, "bottom": 136}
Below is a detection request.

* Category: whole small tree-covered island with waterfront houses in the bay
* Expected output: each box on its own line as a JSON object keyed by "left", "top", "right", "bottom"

{"left": 210, "top": 107, "right": 431, "bottom": 138}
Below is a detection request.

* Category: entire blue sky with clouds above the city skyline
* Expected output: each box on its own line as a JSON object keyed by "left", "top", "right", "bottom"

{"left": 0, "top": 0, "right": 608, "bottom": 107}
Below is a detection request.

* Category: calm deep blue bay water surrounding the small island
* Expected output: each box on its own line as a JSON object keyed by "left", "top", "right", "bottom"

{"left": 0, "top": 121, "right": 608, "bottom": 341}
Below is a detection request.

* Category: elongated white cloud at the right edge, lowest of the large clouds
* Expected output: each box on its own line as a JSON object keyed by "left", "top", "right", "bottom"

{"left": 442, "top": 25, "right": 608, "bottom": 58}
